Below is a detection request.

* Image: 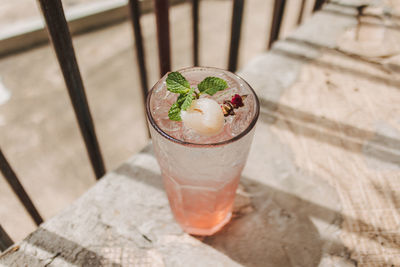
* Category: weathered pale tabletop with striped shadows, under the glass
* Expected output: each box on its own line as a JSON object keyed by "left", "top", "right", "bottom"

{"left": 0, "top": 1, "right": 400, "bottom": 266}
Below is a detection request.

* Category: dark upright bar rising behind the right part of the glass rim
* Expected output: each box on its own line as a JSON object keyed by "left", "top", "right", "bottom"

{"left": 228, "top": 0, "right": 244, "bottom": 72}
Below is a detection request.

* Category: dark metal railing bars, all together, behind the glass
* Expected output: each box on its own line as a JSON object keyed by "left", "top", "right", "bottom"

{"left": 0, "top": 0, "right": 326, "bottom": 251}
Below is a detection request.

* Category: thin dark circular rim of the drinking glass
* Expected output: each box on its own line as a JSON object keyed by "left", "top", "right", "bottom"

{"left": 146, "top": 66, "right": 260, "bottom": 147}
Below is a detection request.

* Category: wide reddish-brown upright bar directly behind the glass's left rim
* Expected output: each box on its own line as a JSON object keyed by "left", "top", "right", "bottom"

{"left": 154, "top": 0, "right": 171, "bottom": 77}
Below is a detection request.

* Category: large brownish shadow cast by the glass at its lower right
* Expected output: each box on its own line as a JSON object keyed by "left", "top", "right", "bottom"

{"left": 200, "top": 177, "right": 352, "bottom": 267}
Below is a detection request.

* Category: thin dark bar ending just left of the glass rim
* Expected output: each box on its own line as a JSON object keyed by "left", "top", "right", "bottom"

{"left": 129, "top": 0, "right": 149, "bottom": 103}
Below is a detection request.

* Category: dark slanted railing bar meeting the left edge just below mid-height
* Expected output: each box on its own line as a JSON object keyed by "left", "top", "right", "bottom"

{"left": 0, "top": 149, "right": 43, "bottom": 225}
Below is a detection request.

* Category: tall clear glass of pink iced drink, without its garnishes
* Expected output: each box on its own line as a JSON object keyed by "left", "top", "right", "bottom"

{"left": 147, "top": 67, "right": 259, "bottom": 235}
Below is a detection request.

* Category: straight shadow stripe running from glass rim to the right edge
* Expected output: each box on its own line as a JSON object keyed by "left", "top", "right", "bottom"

{"left": 260, "top": 99, "right": 400, "bottom": 166}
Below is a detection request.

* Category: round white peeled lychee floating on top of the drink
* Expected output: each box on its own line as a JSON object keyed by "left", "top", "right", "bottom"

{"left": 181, "top": 98, "right": 224, "bottom": 136}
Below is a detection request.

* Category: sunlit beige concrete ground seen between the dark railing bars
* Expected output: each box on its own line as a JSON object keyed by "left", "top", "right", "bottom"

{"left": 0, "top": 0, "right": 313, "bottom": 241}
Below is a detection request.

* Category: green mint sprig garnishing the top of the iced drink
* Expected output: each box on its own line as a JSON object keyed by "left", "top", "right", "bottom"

{"left": 166, "top": 71, "right": 228, "bottom": 121}
